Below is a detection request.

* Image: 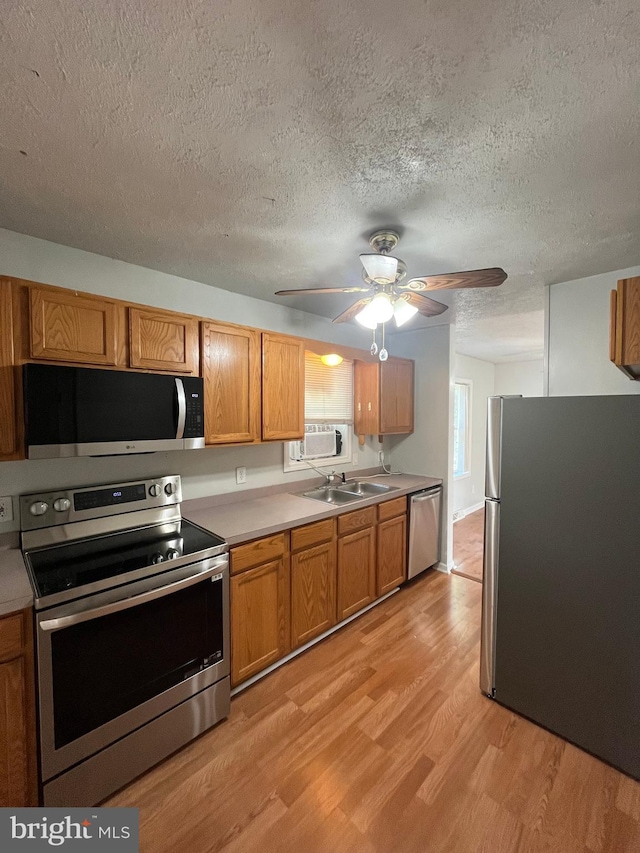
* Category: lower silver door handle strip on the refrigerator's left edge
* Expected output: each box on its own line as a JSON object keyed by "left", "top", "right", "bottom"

{"left": 480, "top": 501, "right": 500, "bottom": 697}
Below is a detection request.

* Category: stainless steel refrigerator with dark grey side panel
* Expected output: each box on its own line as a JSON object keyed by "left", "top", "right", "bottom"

{"left": 480, "top": 395, "right": 640, "bottom": 779}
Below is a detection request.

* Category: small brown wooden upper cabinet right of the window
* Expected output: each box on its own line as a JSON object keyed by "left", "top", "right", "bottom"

{"left": 354, "top": 358, "right": 414, "bottom": 436}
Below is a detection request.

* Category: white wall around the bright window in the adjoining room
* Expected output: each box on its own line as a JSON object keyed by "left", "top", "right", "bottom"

{"left": 453, "top": 353, "right": 499, "bottom": 512}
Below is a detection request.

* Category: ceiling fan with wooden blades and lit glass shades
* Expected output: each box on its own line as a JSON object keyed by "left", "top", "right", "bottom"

{"left": 275, "top": 229, "right": 507, "bottom": 361}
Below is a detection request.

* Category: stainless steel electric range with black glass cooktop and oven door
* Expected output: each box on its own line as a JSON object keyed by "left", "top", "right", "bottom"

{"left": 20, "top": 476, "right": 230, "bottom": 807}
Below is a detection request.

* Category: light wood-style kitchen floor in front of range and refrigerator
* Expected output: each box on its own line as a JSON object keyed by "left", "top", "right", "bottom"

{"left": 105, "top": 570, "right": 640, "bottom": 853}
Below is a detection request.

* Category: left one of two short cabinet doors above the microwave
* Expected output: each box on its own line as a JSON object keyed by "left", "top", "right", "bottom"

{"left": 29, "top": 287, "right": 116, "bottom": 365}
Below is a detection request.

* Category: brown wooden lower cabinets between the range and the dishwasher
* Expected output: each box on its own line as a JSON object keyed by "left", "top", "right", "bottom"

{"left": 231, "top": 497, "right": 407, "bottom": 687}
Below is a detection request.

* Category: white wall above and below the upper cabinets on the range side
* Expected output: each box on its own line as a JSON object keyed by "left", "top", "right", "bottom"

{"left": 0, "top": 229, "right": 378, "bottom": 532}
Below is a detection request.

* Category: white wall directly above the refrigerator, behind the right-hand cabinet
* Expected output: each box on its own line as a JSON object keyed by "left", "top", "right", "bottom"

{"left": 547, "top": 262, "right": 640, "bottom": 396}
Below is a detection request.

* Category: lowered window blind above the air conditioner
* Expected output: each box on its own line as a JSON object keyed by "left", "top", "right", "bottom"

{"left": 304, "top": 352, "right": 353, "bottom": 424}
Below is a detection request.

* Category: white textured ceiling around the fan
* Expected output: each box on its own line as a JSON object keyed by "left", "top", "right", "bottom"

{"left": 0, "top": 0, "right": 640, "bottom": 361}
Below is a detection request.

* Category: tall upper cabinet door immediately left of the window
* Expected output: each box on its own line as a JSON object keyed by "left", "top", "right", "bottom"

{"left": 262, "top": 332, "right": 304, "bottom": 441}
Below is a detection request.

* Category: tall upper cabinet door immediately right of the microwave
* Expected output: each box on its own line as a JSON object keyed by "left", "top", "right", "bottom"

{"left": 202, "top": 322, "right": 260, "bottom": 444}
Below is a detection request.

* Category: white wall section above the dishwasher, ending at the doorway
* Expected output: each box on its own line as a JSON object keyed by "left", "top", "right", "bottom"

{"left": 384, "top": 325, "right": 455, "bottom": 568}
